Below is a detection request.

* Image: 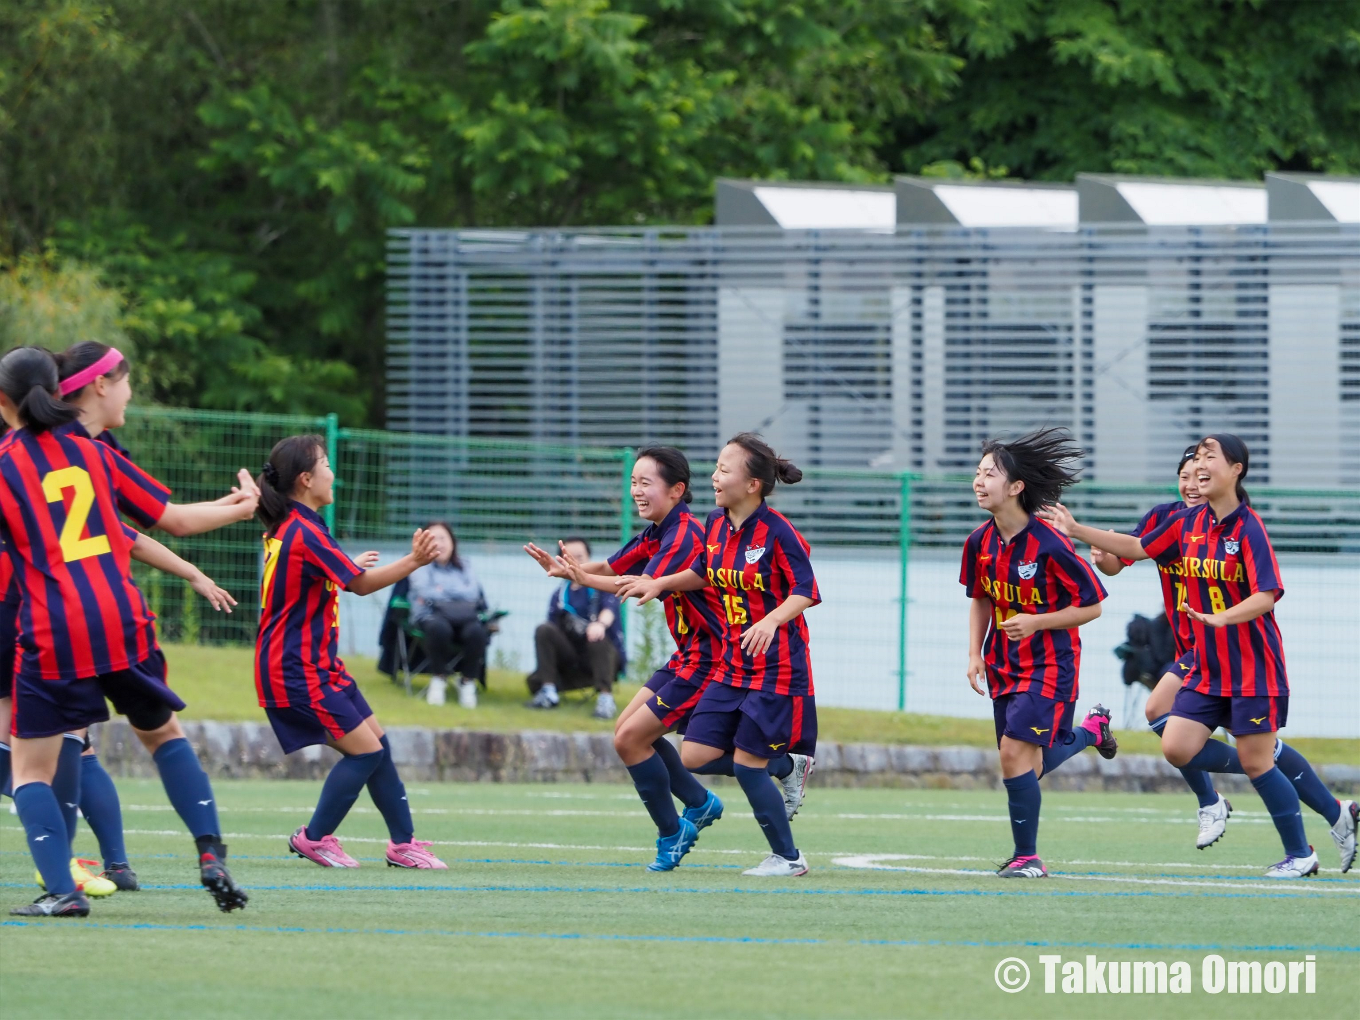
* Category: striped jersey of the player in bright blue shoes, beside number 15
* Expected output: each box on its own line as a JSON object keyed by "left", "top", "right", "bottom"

{"left": 608, "top": 502, "right": 724, "bottom": 680}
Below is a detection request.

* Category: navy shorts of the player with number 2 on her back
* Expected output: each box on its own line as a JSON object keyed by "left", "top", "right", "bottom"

{"left": 10, "top": 649, "right": 185, "bottom": 737}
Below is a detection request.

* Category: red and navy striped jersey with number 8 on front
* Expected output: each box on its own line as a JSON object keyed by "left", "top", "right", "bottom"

{"left": 1141, "top": 503, "right": 1289, "bottom": 698}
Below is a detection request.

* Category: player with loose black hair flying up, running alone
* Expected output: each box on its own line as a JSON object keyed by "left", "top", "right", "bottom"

{"left": 959, "top": 428, "right": 1118, "bottom": 879}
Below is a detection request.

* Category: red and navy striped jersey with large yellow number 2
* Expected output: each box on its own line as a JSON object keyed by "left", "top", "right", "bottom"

{"left": 0, "top": 426, "right": 170, "bottom": 680}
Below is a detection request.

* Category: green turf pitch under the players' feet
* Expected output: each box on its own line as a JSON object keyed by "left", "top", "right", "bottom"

{"left": 0, "top": 781, "right": 1360, "bottom": 1020}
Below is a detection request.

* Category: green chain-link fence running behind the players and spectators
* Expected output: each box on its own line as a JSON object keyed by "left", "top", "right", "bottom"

{"left": 121, "top": 408, "right": 1360, "bottom": 736}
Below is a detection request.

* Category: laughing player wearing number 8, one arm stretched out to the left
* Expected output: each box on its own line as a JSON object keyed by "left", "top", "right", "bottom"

{"left": 1039, "top": 434, "right": 1360, "bottom": 879}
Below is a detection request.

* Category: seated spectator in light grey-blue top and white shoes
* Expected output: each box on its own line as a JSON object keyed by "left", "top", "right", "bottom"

{"left": 409, "top": 521, "right": 487, "bottom": 709}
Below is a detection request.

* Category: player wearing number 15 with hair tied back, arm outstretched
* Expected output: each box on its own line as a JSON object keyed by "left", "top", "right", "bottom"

{"left": 619, "top": 432, "right": 821, "bottom": 877}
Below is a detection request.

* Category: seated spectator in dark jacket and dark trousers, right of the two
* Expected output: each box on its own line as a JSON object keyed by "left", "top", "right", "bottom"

{"left": 528, "top": 539, "right": 626, "bottom": 719}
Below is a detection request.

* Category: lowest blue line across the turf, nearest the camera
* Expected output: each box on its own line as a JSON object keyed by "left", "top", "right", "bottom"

{"left": 0, "top": 919, "right": 1360, "bottom": 953}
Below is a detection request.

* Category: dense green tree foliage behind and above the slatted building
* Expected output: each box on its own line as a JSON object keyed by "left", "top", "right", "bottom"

{"left": 0, "top": 0, "right": 1360, "bottom": 424}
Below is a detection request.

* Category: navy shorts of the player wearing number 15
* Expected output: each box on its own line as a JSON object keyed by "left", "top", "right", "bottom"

{"left": 684, "top": 683, "right": 817, "bottom": 758}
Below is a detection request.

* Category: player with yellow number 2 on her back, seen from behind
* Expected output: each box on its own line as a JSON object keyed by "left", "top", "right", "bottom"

{"left": 0, "top": 347, "right": 253, "bottom": 917}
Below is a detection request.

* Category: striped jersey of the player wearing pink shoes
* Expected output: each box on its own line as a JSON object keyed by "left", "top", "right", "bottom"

{"left": 256, "top": 502, "right": 363, "bottom": 709}
